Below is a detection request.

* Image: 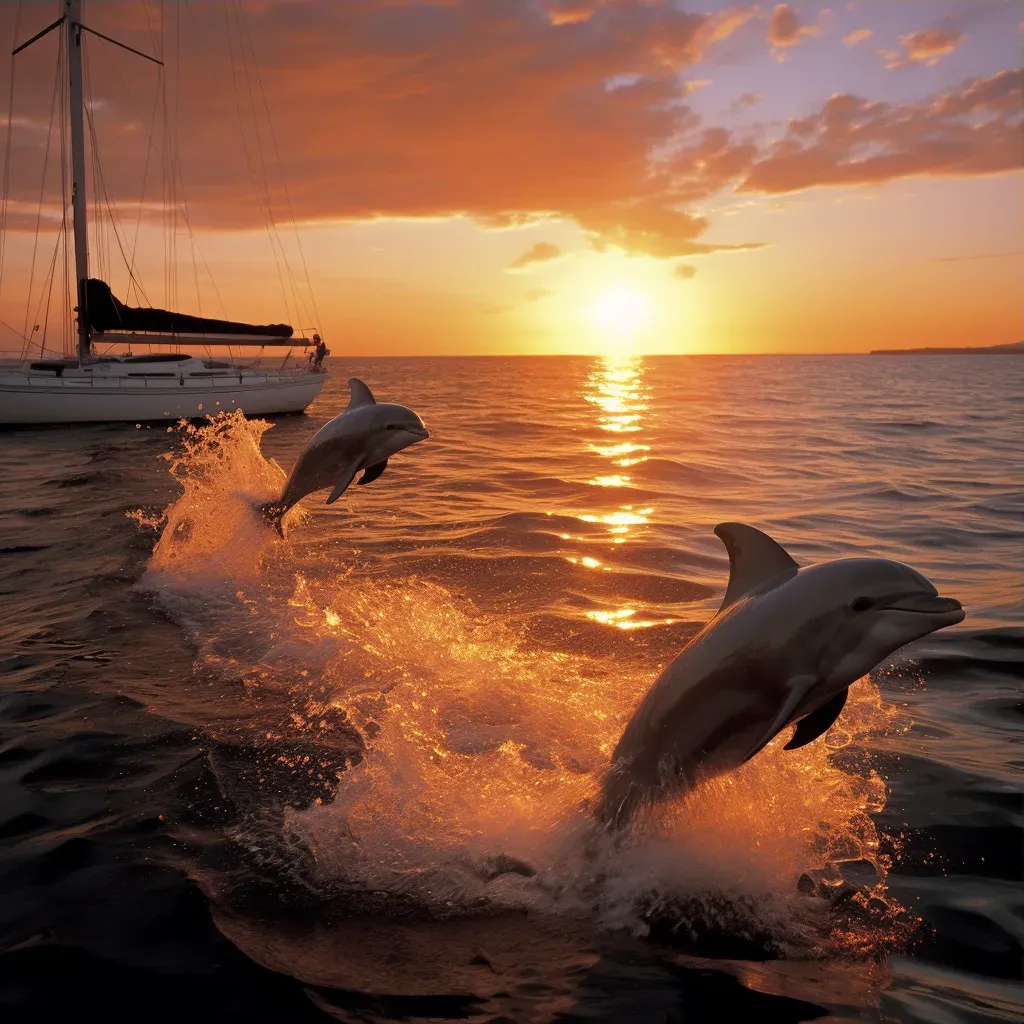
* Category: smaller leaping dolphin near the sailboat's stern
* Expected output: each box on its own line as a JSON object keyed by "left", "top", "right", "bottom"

{"left": 260, "top": 377, "right": 429, "bottom": 531}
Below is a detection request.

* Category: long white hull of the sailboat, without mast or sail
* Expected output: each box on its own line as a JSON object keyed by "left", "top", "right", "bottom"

{"left": 0, "top": 370, "right": 327, "bottom": 425}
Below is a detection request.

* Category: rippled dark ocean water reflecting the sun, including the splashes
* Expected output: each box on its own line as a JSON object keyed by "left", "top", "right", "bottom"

{"left": 0, "top": 356, "right": 1024, "bottom": 1024}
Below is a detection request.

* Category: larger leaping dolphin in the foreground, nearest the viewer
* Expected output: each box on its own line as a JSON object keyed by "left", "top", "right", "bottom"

{"left": 596, "top": 522, "right": 964, "bottom": 829}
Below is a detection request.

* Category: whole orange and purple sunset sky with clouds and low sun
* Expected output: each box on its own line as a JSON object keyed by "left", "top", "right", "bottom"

{"left": 0, "top": 0, "right": 1024, "bottom": 355}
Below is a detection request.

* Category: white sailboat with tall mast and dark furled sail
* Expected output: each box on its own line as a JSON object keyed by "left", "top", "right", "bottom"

{"left": 0, "top": 0, "right": 326, "bottom": 425}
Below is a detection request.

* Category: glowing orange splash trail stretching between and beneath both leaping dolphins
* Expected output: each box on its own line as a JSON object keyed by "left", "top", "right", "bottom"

{"left": 134, "top": 413, "right": 913, "bottom": 952}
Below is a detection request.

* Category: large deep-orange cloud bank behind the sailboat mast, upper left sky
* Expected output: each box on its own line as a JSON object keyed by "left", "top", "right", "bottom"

{"left": 0, "top": 0, "right": 761, "bottom": 256}
